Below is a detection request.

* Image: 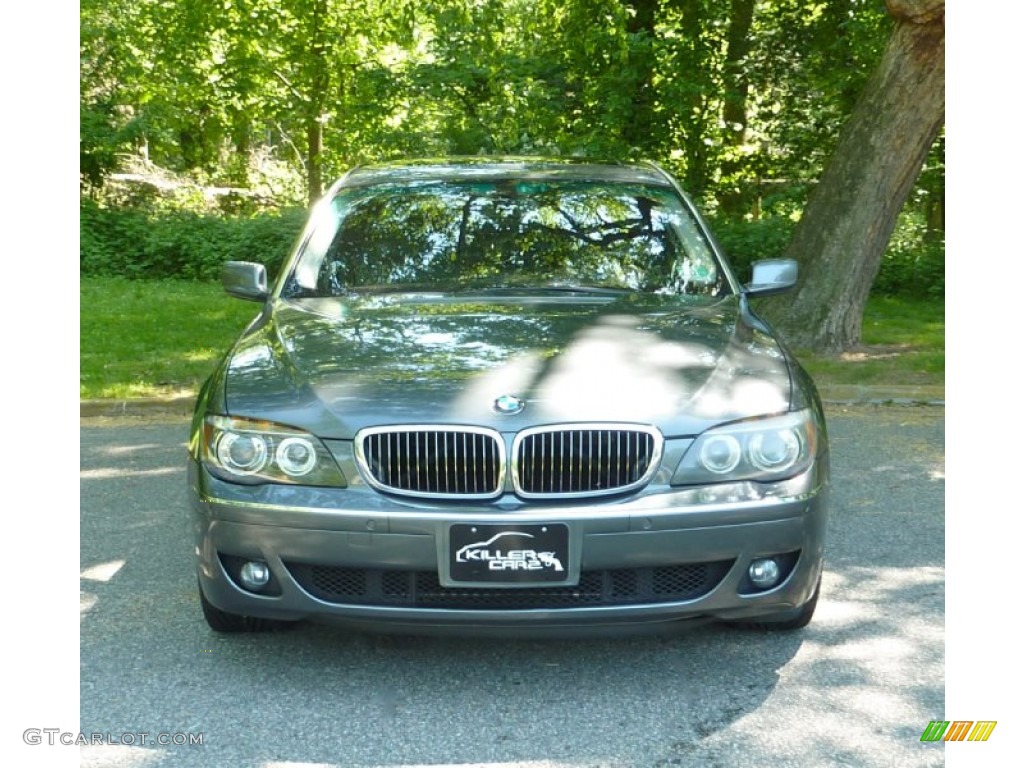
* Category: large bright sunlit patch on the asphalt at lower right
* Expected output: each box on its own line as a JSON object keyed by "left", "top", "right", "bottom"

{"left": 688, "top": 568, "right": 944, "bottom": 766}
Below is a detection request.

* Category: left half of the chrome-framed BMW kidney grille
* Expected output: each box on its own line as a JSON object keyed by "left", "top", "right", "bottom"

{"left": 355, "top": 425, "right": 505, "bottom": 499}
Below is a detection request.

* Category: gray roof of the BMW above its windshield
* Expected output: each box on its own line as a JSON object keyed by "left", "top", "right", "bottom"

{"left": 335, "top": 157, "right": 672, "bottom": 187}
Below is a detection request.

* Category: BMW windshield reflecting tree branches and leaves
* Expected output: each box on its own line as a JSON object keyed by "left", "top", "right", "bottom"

{"left": 282, "top": 179, "right": 729, "bottom": 298}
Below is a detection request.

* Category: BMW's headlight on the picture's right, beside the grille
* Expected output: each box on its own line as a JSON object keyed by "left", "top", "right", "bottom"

{"left": 672, "top": 410, "right": 818, "bottom": 485}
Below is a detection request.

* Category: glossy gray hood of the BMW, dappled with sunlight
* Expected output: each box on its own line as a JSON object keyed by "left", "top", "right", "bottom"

{"left": 221, "top": 295, "right": 791, "bottom": 439}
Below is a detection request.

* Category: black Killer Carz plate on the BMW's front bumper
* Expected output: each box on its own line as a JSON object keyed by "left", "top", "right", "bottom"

{"left": 449, "top": 523, "right": 569, "bottom": 584}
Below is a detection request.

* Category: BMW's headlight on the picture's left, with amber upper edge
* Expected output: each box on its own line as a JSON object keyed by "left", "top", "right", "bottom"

{"left": 203, "top": 416, "right": 345, "bottom": 486}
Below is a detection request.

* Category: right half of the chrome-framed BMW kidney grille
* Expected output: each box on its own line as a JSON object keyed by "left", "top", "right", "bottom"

{"left": 512, "top": 424, "right": 663, "bottom": 499}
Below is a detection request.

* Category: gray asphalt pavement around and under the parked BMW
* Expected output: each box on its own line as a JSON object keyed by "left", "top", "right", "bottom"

{"left": 74, "top": 403, "right": 945, "bottom": 768}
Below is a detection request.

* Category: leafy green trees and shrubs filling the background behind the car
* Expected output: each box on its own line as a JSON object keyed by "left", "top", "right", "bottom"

{"left": 80, "top": 0, "right": 944, "bottom": 295}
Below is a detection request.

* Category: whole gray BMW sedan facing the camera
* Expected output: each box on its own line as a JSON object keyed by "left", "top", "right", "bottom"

{"left": 188, "top": 158, "right": 829, "bottom": 634}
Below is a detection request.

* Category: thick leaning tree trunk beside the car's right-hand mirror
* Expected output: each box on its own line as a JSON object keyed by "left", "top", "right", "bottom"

{"left": 766, "top": 0, "right": 945, "bottom": 352}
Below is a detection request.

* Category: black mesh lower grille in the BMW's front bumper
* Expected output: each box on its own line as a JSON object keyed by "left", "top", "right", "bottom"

{"left": 286, "top": 560, "right": 734, "bottom": 610}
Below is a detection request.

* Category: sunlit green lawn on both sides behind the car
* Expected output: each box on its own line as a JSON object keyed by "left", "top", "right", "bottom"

{"left": 79, "top": 278, "right": 945, "bottom": 398}
